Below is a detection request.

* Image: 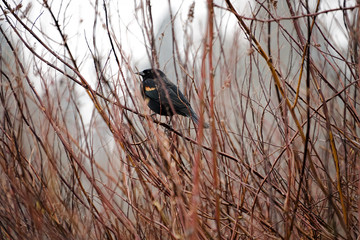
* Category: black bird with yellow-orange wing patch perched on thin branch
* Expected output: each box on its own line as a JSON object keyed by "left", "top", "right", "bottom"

{"left": 136, "top": 69, "right": 208, "bottom": 127}
